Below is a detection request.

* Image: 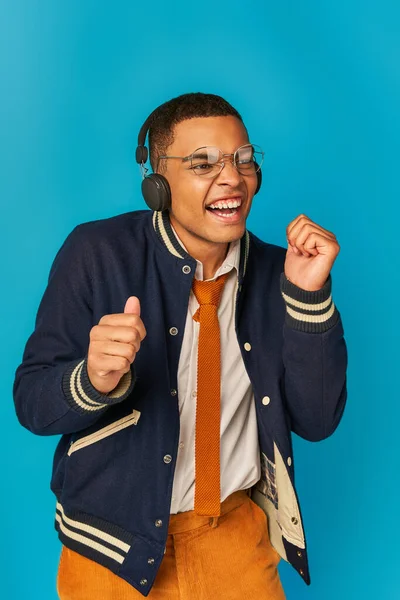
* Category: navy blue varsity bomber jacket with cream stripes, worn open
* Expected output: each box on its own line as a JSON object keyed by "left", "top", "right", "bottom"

{"left": 14, "top": 211, "right": 347, "bottom": 596}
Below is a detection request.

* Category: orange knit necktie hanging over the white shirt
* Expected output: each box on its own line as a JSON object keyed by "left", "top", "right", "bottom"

{"left": 193, "top": 274, "right": 228, "bottom": 517}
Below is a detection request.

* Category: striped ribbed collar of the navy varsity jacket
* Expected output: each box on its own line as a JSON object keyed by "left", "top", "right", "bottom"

{"left": 153, "top": 210, "right": 250, "bottom": 283}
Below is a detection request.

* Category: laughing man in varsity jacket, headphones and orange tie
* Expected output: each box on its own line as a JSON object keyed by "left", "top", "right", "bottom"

{"left": 14, "top": 94, "right": 347, "bottom": 600}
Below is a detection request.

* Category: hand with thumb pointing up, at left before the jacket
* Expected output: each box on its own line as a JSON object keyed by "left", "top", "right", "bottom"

{"left": 87, "top": 296, "right": 146, "bottom": 394}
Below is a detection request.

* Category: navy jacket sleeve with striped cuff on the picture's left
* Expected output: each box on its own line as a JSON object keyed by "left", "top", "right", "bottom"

{"left": 13, "top": 225, "right": 134, "bottom": 435}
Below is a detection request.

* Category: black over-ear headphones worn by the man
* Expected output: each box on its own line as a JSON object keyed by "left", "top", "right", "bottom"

{"left": 136, "top": 109, "right": 262, "bottom": 210}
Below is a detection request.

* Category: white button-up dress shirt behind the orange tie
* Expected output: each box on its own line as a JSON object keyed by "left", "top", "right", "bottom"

{"left": 171, "top": 231, "right": 260, "bottom": 514}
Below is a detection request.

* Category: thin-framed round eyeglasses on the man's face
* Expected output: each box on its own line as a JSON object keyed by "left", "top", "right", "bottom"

{"left": 157, "top": 144, "right": 264, "bottom": 178}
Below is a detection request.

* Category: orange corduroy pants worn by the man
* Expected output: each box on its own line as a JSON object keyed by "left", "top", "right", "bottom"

{"left": 57, "top": 491, "right": 285, "bottom": 600}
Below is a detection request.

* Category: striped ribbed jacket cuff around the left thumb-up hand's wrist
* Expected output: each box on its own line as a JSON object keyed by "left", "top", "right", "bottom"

{"left": 62, "top": 358, "right": 135, "bottom": 414}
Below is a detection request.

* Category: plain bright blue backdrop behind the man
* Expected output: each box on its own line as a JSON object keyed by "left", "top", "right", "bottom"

{"left": 0, "top": 0, "right": 400, "bottom": 600}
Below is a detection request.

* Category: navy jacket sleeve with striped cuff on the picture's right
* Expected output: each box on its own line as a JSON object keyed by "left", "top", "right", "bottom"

{"left": 280, "top": 273, "right": 347, "bottom": 441}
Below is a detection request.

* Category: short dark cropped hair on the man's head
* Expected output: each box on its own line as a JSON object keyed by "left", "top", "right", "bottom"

{"left": 149, "top": 92, "right": 243, "bottom": 171}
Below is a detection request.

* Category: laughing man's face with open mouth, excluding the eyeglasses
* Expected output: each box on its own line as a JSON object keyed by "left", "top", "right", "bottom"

{"left": 163, "top": 116, "right": 257, "bottom": 253}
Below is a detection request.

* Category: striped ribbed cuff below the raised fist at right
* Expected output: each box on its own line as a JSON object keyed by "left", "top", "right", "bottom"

{"left": 280, "top": 273, "right": 339, "bottom": 333}
